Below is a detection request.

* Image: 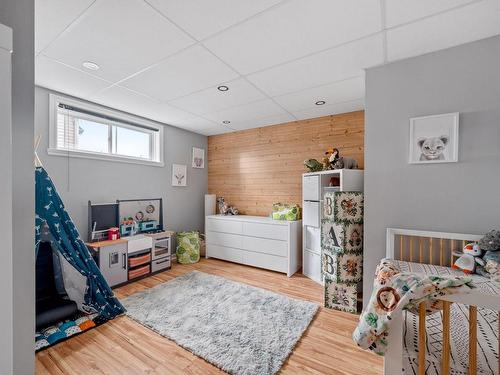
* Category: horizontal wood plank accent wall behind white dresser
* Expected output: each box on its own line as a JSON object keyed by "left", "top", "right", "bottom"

{"left": 207, "top": 111, "right": 365, "bottom": 216}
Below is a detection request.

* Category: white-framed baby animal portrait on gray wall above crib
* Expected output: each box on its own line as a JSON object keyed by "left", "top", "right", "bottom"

{"left": 409, "top": 112, "right": 459, "bottom": 164}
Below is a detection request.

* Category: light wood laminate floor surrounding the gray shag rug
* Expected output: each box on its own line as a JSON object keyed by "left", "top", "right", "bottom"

{"left": 36, "top": 259, "right": 382, "bottom": 375}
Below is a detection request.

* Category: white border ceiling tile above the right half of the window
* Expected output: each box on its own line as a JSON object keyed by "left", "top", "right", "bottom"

{"left": 92, "top": 86, "right": 193, "bottom": 125}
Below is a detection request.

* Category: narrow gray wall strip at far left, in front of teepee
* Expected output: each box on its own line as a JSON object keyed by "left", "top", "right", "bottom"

{"left": 0, "top": 0, "right": 35, "bottom": 375}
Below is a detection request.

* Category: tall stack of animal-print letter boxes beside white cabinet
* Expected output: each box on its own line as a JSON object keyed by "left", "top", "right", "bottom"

{"left": 321, "top": 191, "right": 364, "bottom": 313}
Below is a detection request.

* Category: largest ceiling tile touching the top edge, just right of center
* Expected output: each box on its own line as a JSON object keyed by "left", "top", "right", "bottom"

{"left": 204, "top": 0, "right": 381, "bottom": 74}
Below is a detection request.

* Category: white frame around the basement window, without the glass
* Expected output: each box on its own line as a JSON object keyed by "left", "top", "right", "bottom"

{"left": 47, "top": 94, "right": 165, "bottom": 167}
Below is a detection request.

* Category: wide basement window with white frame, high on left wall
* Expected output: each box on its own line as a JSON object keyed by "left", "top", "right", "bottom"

{"left": 48, "top": 95, "right": 163, "bottom": 166}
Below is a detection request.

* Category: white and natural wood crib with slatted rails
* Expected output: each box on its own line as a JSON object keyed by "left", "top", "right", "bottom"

{"left": 384, "top": 228, "right": 500, "bottom": 375}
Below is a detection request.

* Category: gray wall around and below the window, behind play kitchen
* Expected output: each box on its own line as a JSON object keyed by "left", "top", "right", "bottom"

{"left": 35, "top": 87, "right": 208, "bottom": 239}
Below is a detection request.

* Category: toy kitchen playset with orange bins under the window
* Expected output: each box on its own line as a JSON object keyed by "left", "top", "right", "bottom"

{"left": 87, "top": 198, "right": 175, "bottom": 287}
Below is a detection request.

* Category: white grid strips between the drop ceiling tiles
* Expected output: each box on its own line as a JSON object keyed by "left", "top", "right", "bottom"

{"left": 37, "top": 0, "right": 500, "bottom": 134}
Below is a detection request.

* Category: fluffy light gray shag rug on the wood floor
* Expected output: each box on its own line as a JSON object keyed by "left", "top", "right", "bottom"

{"left": 121, "top": 271, "right": 318, "bottom": 375}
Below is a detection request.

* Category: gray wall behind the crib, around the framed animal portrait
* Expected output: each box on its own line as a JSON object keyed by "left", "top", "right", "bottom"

{"left": 364, "top": 37, "right": 500, "bottom": 304}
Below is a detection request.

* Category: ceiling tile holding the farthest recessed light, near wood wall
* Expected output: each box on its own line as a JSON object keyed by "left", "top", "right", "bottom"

{"left": 204, "top": 99, "right": 286, "bottom": 124}
